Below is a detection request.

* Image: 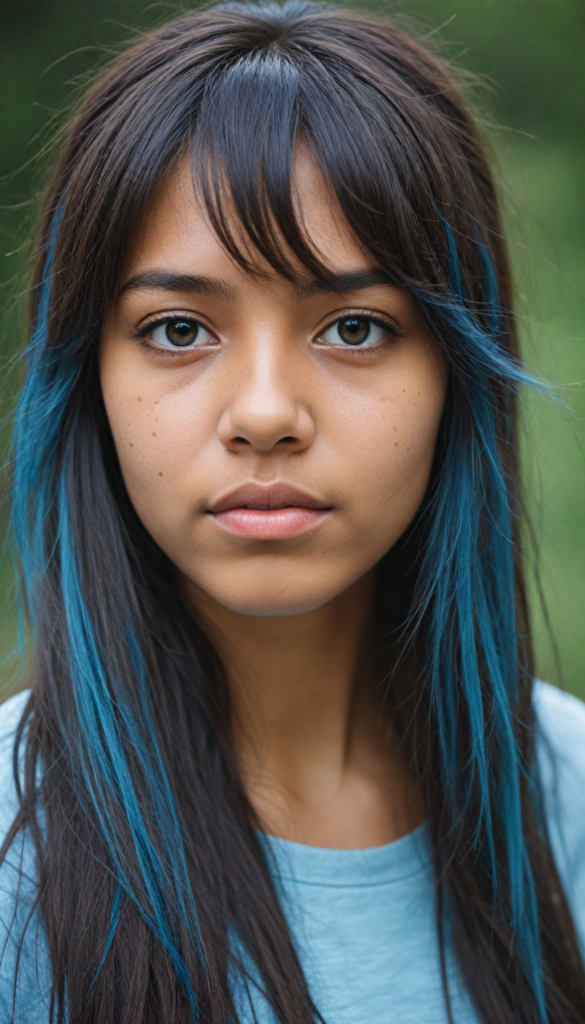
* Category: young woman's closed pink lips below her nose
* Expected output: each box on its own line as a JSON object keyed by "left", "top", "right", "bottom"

{"left": 207, "top": 482, "right": 332, "bottom": 541}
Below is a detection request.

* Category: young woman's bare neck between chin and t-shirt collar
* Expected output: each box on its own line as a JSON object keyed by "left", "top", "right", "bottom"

{"left": 187, "top": 571, "right": 420, "bottom": 848}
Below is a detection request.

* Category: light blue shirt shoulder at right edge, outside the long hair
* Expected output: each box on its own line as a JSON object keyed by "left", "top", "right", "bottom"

{"left": 534, "top": 682, "right": 585, "bottom": 941}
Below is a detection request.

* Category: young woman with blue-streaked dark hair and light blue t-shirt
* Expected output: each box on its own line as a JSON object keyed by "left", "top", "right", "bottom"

{"left": 0, "top": 0, "right": 585, "bottom": 1024}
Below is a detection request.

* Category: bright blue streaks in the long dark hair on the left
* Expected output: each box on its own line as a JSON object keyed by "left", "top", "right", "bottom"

{"left": 12, "top": 204, "right": 205, "bottom": 1020}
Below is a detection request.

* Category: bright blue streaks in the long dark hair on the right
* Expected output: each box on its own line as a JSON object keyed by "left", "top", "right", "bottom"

{"left": 411, "top": 214, "right": 550, "bottom": 1024}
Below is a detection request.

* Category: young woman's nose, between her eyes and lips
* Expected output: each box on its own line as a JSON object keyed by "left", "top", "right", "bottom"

{"left": 218, "top": 339, "right": 316, "bottom": 452}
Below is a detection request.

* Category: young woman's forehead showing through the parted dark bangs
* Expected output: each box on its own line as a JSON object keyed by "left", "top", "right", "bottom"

{"left": 125, "top": 145, "right": 371, "bottom": 281}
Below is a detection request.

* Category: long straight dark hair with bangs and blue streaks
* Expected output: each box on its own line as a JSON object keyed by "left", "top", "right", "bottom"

{"left": 3, "top": 0, "right": 585, "bottom": 1024}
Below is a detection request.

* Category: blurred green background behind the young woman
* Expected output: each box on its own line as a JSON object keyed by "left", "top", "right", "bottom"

{"left": 0, "top": 0, "right": 585, "bottom": 698}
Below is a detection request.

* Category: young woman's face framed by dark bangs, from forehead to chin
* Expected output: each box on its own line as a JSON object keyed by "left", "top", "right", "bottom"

{"left": 100, "top": 151, "right": 447, "bottom": 615}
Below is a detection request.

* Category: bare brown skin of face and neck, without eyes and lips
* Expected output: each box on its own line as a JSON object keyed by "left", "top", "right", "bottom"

{"left": 100, "top": 152, "right": 447, "bottom": 848}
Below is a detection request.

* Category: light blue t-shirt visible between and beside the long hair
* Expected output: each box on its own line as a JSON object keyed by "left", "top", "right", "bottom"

{"left": 0, "top": 683, "right": 585, "bottom": 1024}
